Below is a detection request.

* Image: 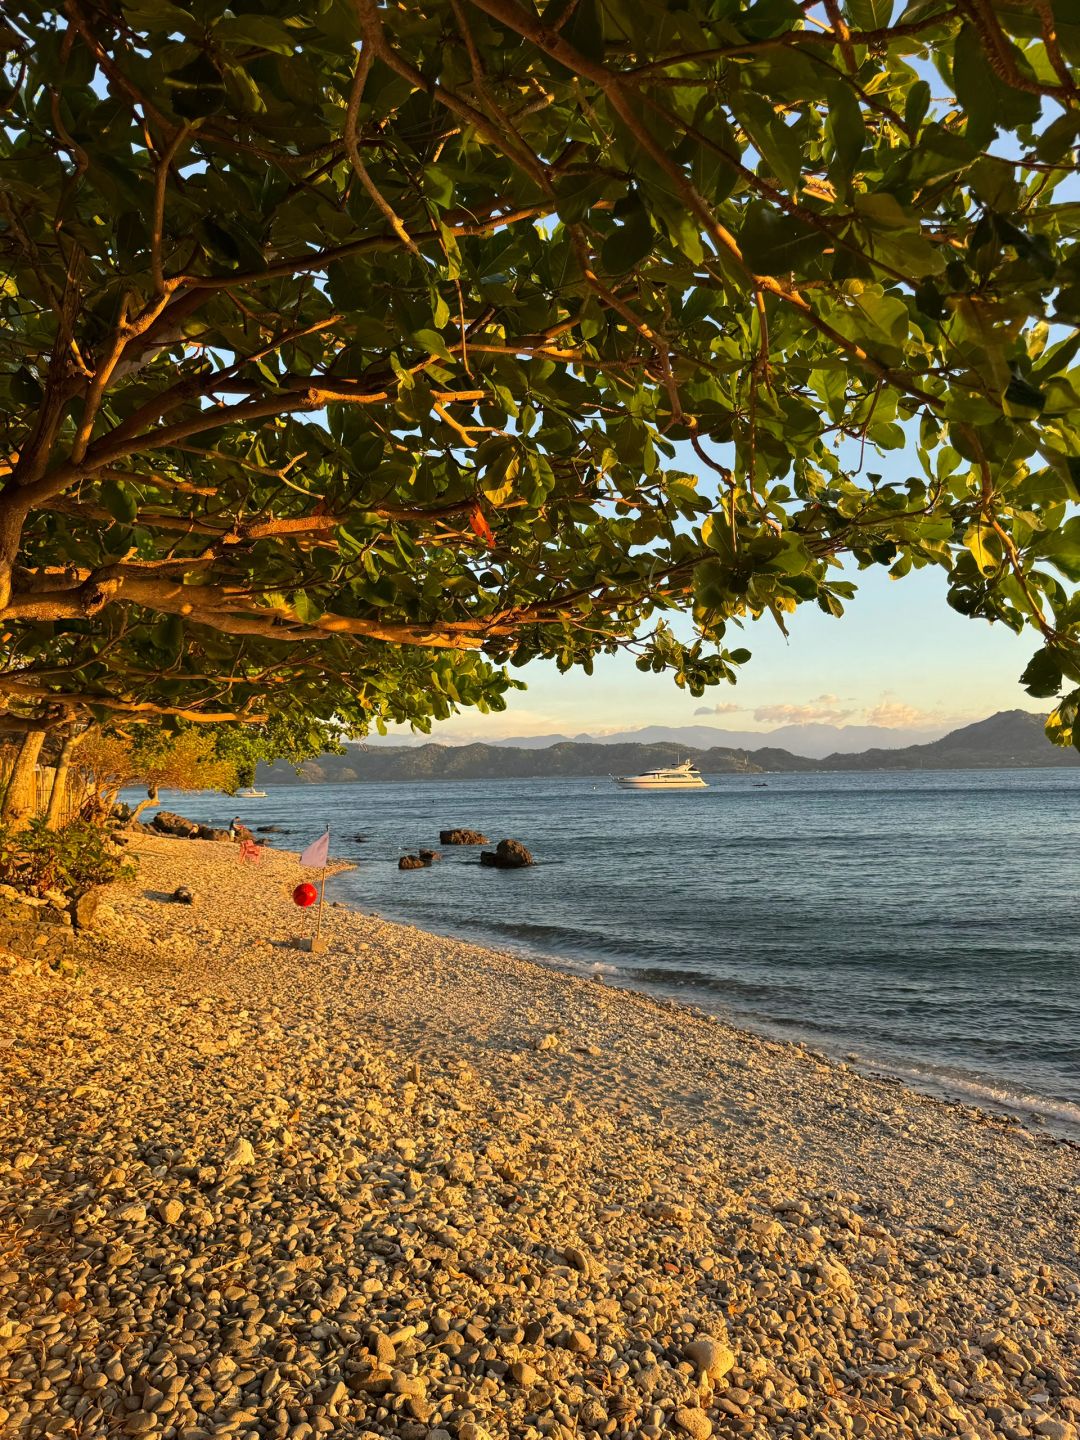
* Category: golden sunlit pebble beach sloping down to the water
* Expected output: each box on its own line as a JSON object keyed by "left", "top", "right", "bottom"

{"left": 0, "top": 834, "right": 1080, "bottom": 1440}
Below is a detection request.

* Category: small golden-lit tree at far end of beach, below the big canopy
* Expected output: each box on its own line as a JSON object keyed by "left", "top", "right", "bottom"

{"left": 75, "top": 726, "right": 238, "bottom": 821}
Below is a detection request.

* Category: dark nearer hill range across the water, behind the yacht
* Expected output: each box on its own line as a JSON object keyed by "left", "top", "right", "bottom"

{"left": 258, "top": 710, "right": 1080, "bottom": 785}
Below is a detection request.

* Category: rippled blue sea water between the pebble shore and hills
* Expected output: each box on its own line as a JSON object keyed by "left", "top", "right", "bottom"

{"left": 164, "top": 769, "right": 1080, "bottom": 1129}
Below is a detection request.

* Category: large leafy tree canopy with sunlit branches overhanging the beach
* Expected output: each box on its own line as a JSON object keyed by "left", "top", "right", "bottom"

{"left": 0, "top": 11, "right": 1080, "bottom": 739}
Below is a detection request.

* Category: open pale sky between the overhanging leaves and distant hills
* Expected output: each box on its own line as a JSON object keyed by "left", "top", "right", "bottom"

{"left": 394, "top": 555, "right": 1051, "bottom": 740}
